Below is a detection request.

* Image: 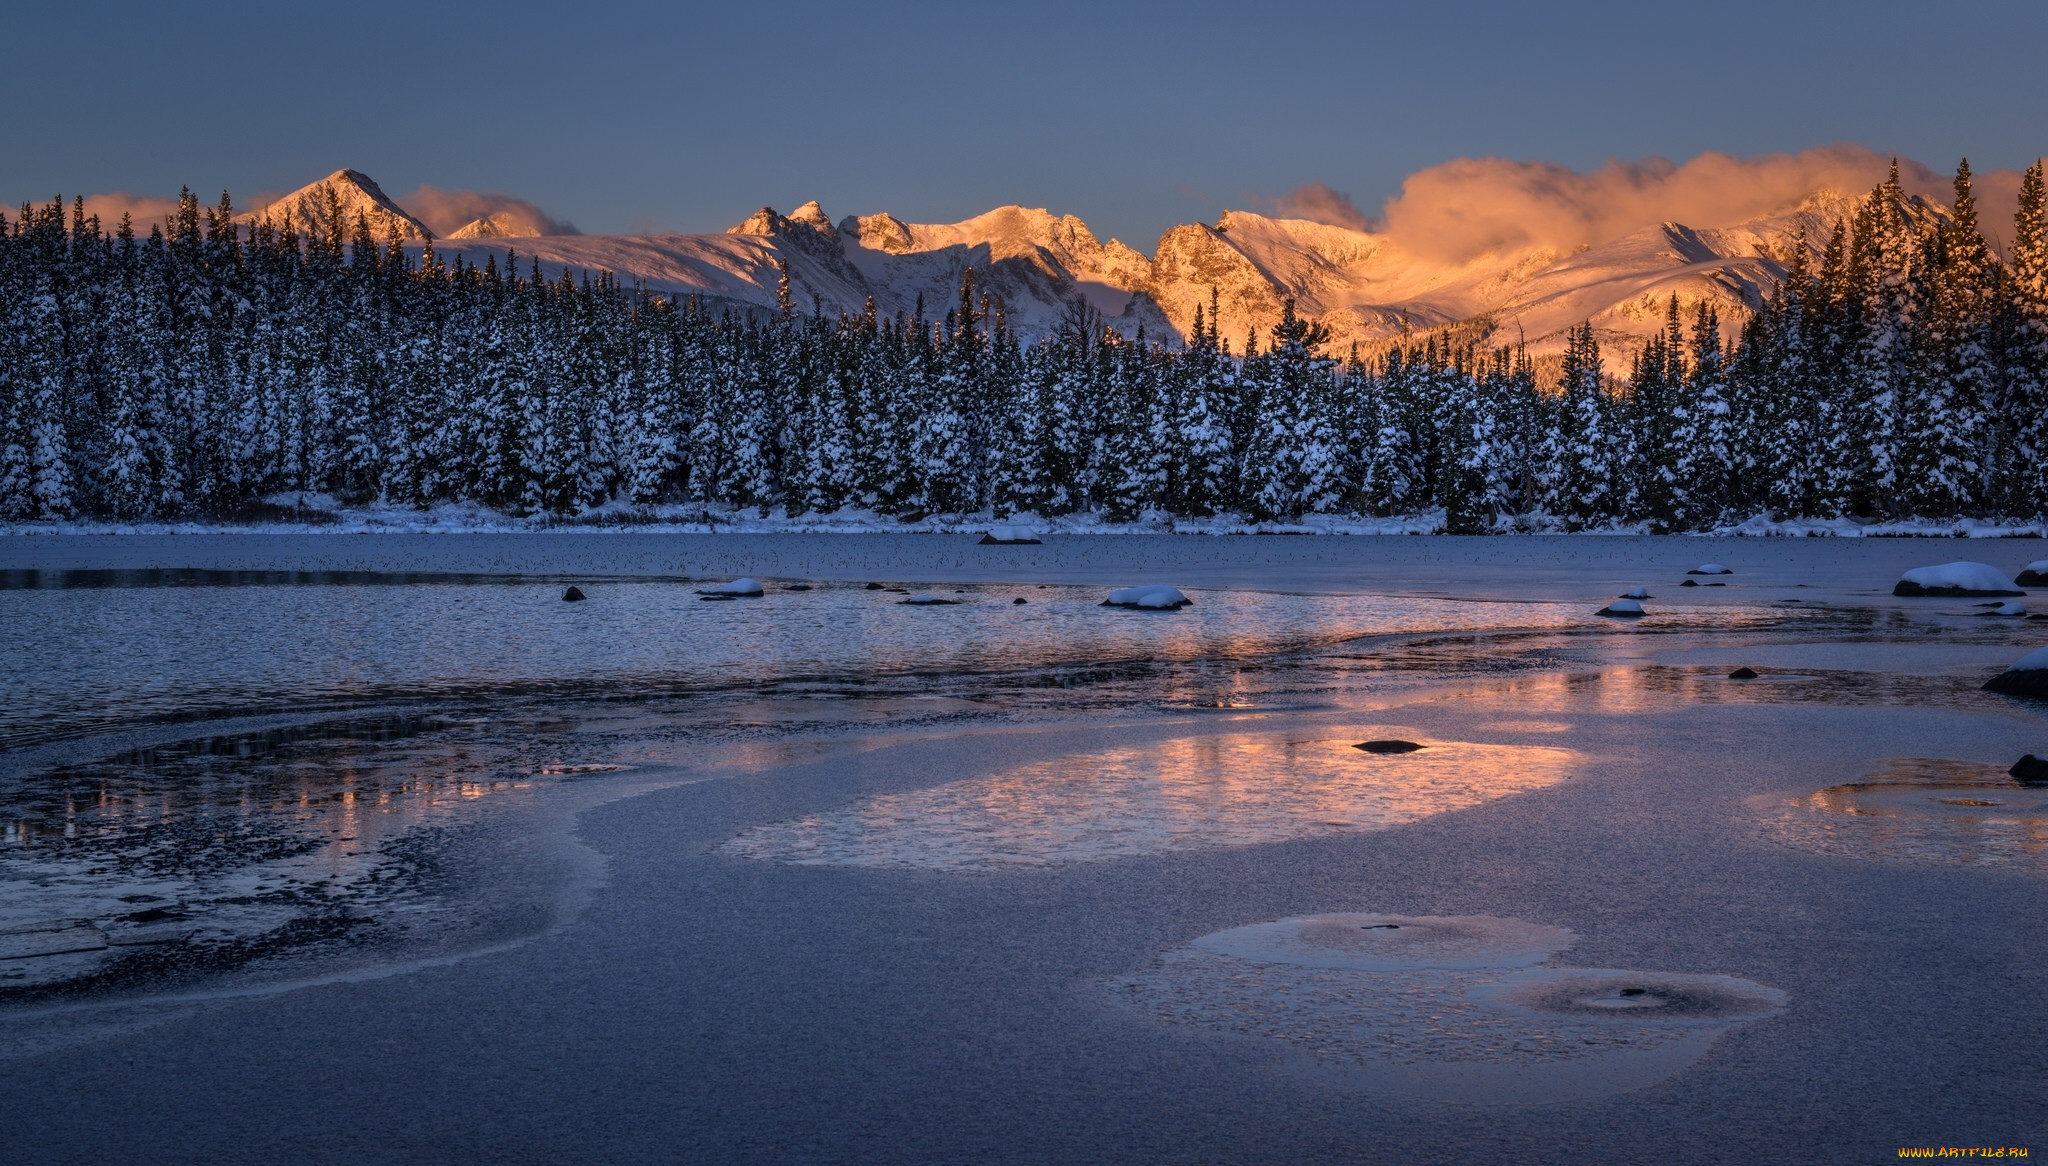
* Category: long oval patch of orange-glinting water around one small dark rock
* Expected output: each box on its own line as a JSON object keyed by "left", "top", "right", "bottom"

{"left": 725, "top": 725, "right": 1579, "bottom": 871}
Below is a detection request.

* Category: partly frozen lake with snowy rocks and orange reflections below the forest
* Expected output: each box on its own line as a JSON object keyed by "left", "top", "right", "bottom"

{"left": 0, "top": 535, "right": 2048, "bottom": 1162}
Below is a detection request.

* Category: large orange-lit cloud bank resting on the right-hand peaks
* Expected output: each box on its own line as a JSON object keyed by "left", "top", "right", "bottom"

{"left": 1378, "top": 143, "right": 2019, "bottom": 260}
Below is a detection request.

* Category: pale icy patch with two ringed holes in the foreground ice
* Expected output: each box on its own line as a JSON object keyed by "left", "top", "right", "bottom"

{"left": 1110, "top": 916, "right": 1786, "bottom": 1105}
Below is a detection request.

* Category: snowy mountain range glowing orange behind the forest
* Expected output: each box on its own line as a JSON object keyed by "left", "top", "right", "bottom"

{"left": 246, "top": 170, "right": 1948, "bottom": 352}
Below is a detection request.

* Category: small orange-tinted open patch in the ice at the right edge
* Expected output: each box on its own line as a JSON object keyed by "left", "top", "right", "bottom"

{"left": 1769, "top": 758, "right": 2048, "bottom": 871}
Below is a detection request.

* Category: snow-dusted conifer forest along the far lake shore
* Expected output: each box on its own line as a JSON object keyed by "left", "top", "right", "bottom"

{"left": 0, "top": 164, "right": 2048, "bottom": 533}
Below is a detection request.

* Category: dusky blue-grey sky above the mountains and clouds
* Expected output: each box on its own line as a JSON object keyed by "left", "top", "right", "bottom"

{"left": 0, "top": 0, "right": 2048, "bottom": 250}
